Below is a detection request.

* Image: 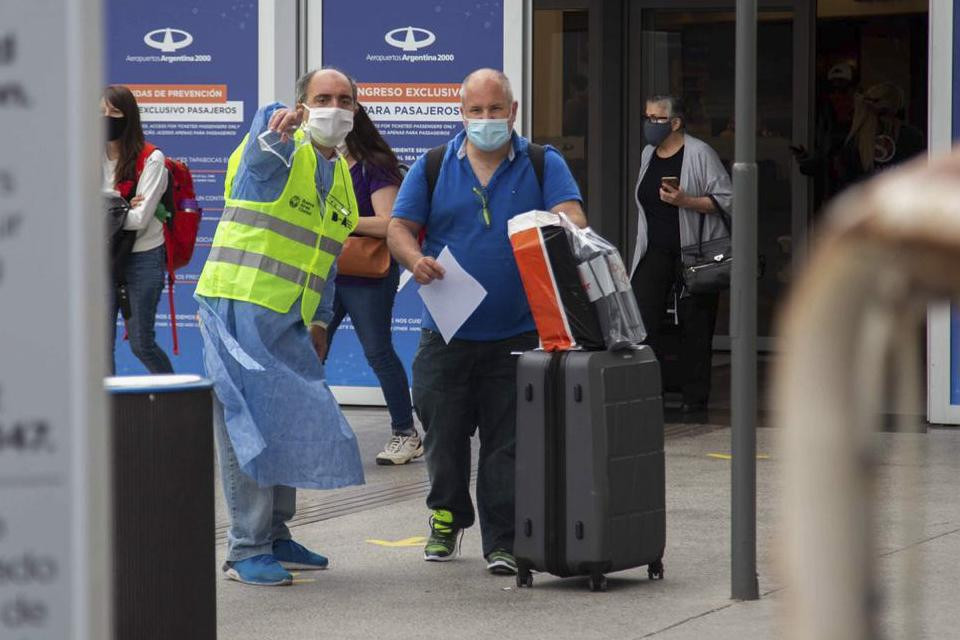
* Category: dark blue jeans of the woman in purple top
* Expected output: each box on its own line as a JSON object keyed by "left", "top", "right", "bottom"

{"left": 327, "top": 263, "right": 414, "bottom": 434}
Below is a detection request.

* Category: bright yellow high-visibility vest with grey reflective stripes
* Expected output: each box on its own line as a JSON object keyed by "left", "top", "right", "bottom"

{"left": 197, "top": 131, "right": 359, "bottom": 325}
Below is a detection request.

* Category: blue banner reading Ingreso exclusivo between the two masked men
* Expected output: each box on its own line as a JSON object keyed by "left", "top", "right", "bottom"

{"left": 322, "top": 0, "right": 504, "bottom": 388}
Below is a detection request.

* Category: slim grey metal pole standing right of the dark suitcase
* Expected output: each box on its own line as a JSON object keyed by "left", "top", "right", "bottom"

{"left": 730, "top": 0, "right": 759, "bottom": 600}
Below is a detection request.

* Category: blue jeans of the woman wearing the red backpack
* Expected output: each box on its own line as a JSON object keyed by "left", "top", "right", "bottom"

{"left": 108, "top": 245, "right": 173, "bottom": 373}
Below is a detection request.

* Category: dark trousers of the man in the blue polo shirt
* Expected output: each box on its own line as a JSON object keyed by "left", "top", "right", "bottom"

{"left": 413, "top": 330, "right": 538, "bottom": 555}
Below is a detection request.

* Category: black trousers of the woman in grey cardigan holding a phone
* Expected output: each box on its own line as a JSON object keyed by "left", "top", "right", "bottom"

{"left": 631, "top": 246, "right": 720, "bottom": 404}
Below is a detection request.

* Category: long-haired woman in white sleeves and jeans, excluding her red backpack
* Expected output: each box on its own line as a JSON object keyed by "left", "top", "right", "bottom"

{"left": 101, "top": 85, "right": 173, "bottom": 373}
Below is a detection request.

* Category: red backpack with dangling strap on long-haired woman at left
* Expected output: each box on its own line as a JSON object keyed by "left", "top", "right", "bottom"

{"left": 117, "top": 142, "right": 203, "bottom": 355}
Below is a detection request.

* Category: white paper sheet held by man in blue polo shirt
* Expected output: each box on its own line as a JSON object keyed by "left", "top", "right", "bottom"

{"left": 420, "top": 247, "right": 487, "bottom": 344}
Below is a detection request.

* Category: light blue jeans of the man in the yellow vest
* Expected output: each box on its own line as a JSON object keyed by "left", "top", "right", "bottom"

{"left": 213, "top": 395, "right": 297, "bottom": 562}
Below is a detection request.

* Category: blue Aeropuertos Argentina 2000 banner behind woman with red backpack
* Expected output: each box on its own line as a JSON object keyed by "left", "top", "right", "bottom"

{"left": 105, "top": 0, "right": 258, "bottom": 375}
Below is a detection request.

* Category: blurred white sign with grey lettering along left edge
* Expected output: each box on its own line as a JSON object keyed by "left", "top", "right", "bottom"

{"left": 0, "top": 0, "right": 111, "bottom": 640}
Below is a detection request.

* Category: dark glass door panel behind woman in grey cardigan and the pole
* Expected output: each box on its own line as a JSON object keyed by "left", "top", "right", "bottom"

{"left": 631, "top": 10, "right": 793, "bottom": 336}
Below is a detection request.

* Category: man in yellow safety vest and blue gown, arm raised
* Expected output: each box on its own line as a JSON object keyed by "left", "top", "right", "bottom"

{"left": 196, "top": 69, "right": 363, "bottom": 586}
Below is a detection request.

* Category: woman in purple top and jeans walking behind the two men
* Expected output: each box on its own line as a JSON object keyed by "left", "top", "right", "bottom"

{"left": 327, "top": 104, "right": 423, "bottom": 465}
